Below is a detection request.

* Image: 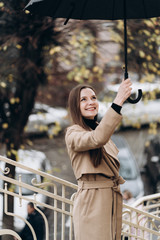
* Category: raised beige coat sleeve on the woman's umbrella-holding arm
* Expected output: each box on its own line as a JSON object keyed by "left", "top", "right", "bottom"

{"left": 65, "top": 108, "right": 122, "bottom": 152}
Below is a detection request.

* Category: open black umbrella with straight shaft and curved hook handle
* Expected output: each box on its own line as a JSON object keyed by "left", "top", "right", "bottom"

{"left": 25, "top": 0, "right": 160, "bottom": 103}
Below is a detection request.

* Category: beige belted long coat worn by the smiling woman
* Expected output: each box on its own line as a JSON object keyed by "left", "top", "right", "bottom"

{"left": 65, "top": 108, "right": 124, "bottom": 240}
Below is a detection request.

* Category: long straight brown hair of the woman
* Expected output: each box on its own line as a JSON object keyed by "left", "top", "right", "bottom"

{"left": 68, "top": 84, "right": 103, "bottom": 167}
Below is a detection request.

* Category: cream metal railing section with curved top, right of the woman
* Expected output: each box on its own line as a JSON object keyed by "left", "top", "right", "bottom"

{"left": 122, "top": 193, "right": 160, "bottom": 240}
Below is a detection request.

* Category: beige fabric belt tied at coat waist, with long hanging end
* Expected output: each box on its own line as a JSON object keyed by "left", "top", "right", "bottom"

{"left": 78, "top": 176, "right": 125, "bottom": 240}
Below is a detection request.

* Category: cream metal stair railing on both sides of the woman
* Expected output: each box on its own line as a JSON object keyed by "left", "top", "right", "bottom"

{"left": 0, "top": 156, "right": 160, "bottom": 240}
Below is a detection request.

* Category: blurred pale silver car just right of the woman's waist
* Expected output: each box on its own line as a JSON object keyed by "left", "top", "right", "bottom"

{"left": 112, "top": 135, "right": 144, "bottom": 199}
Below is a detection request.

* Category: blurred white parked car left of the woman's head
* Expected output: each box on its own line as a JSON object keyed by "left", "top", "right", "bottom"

{"left": 25, "top": 103, "right": 69, "bottom": 136}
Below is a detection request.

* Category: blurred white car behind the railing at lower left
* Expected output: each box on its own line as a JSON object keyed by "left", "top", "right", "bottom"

{"left": 0, "top": 149, "right": 51, "bottom": 231}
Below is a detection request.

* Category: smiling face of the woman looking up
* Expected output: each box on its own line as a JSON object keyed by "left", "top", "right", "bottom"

{"left": 80, "top": 88, "right": 99, "bottom": 119}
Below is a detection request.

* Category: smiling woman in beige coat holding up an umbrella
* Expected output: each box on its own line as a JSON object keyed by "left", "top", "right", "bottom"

{"left": 65, "top": 79, "right": 131, "bottom": 240}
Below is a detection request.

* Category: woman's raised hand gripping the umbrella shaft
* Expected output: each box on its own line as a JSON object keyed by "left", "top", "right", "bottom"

{"left": 113, "top": 78, "right": 132, "bottom": 106}
